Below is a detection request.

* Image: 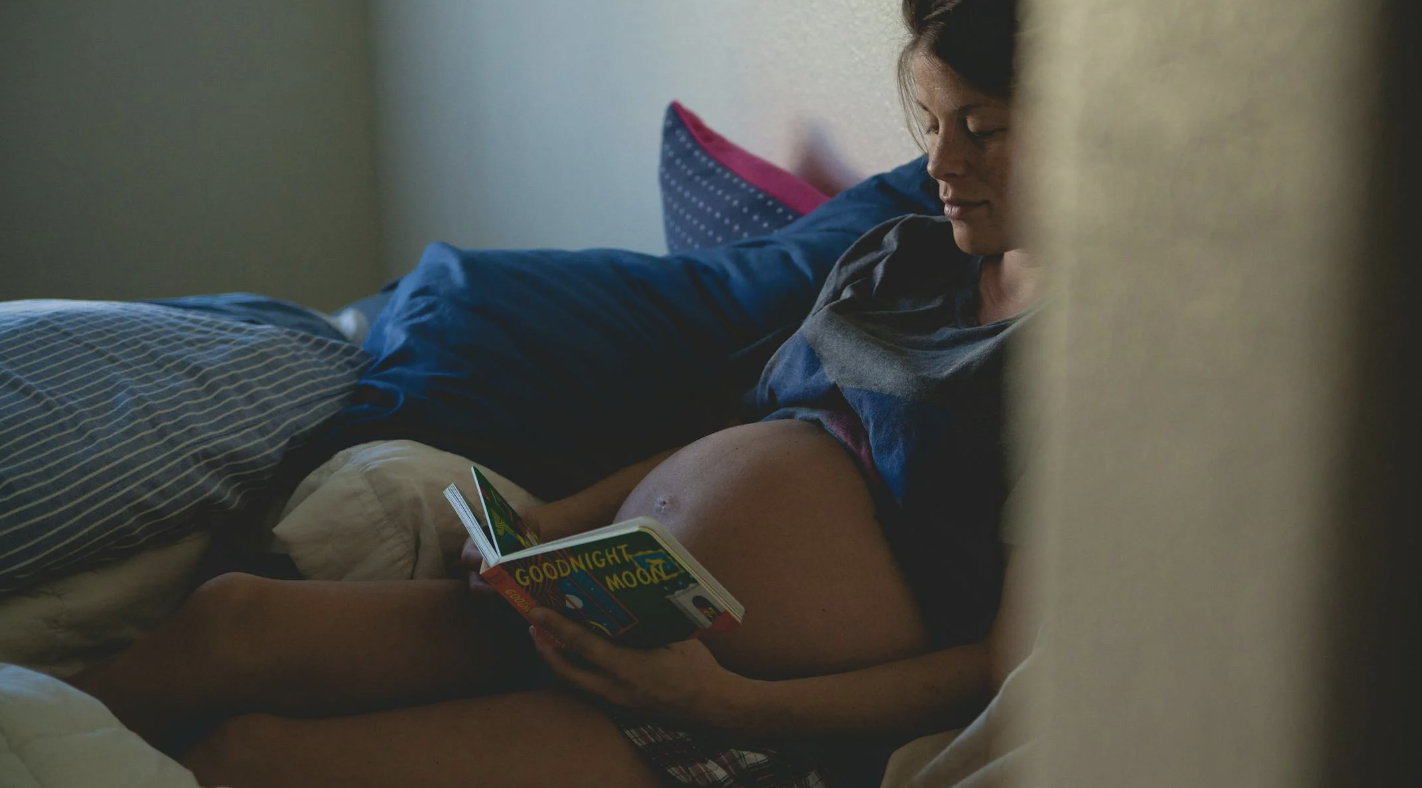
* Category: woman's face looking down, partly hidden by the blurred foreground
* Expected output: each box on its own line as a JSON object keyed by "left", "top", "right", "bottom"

{"left": 913, "top": 54, "right": 1018, "bottom": 255}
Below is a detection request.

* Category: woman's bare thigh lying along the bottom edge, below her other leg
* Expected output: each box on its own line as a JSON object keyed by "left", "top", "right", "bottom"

{"left": 183, "top": 690, "right": 661, "bottom": 788}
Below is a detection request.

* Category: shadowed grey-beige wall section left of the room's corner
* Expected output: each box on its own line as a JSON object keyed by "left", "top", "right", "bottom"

{"left": 0, "top": 0, "right": 380, "bottom": 307}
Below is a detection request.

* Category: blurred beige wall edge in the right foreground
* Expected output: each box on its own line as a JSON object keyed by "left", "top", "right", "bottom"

{"left": 1020, "top": 0, "right": 1422, "bottom": 788}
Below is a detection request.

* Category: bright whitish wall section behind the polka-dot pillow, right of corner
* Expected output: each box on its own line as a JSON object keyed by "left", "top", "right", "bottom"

{"left": 374, "top": 0, "right": 917, "bottom": 275}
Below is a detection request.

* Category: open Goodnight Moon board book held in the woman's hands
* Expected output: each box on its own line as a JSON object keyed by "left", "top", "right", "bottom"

{"left": 445, "top": 468, "right": 745, "bottom": 649}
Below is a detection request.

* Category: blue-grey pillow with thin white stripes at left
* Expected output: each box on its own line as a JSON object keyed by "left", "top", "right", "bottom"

{"left": 0, "top": 302, "right": 367, "bottom": 592}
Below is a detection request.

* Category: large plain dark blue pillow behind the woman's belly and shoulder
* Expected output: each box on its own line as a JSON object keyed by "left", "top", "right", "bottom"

{"left": 322, "top": 158, "right": 943, "bottom": 498}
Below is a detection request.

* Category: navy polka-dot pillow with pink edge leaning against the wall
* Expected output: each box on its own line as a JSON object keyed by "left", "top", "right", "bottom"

{"left": 660, "top": 101, "right": 829, "bottom": 253}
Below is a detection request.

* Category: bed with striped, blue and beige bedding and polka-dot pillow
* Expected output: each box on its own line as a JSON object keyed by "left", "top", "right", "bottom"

{"left": 0, "top": 104, "right": 989, "bottom": 788}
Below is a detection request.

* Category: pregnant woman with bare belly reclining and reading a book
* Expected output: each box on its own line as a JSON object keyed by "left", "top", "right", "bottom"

{"left": 74, "top": 0, "right": 1039, "bottom": 788}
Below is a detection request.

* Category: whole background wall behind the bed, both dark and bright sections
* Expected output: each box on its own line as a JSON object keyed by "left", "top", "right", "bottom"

{"left": 0, "top": 0, "right": 916, "bottom": 297}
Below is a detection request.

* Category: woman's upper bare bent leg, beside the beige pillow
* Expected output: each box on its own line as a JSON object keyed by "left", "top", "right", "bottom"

{"left": 71, "top": 575, "right": 538, "bottom": 750}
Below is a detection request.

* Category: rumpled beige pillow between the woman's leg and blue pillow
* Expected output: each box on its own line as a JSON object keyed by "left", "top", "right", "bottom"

{"left": 272, "top": 441, "right": 539, "bottom": 580}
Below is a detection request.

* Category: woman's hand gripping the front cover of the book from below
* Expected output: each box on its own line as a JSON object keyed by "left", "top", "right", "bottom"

{"left": 529, "top": 607, "right": 754, "bottom": 728}
